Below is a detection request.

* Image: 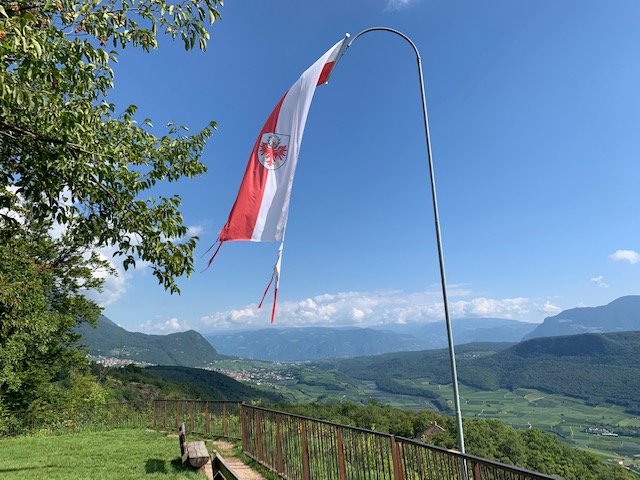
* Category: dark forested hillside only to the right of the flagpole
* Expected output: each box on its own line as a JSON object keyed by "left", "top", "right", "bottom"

{"left": 459, "top": 332, "right": 640, "bottom": 413}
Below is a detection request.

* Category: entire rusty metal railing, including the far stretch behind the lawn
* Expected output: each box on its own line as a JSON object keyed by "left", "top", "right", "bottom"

{"left": 0, "top": 400, "right": 557, "bottom": 480}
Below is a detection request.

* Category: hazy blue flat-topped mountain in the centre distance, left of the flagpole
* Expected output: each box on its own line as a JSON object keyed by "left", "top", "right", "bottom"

{"left": 206, "top": 327, "right": 425, "bottom": 361}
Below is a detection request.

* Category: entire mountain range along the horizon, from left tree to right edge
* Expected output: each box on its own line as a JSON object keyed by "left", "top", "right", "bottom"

{"left": 78, "top": 295, "right": 640, "bottom": 367}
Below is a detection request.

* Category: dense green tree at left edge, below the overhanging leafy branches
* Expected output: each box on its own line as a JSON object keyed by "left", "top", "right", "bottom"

{"left": 0, "top": 216, "right": 106, "bottom": 409}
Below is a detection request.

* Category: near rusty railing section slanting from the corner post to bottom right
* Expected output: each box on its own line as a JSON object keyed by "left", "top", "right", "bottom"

{"left": 242, "top": 405, "right": 557, "bottom": 480}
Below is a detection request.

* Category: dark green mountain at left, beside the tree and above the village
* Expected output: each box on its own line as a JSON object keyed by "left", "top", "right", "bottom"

{"left": 77, "top": 316, "right": 220, "bottom": 367}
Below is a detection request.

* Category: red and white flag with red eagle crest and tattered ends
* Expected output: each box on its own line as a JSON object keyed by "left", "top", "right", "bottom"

{"left": 209, "top": 36, "right": 348, "bottom": 322}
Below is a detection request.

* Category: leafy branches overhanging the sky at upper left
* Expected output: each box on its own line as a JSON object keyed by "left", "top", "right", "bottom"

{"left": 0, "top": 0, "right": 222, "bottom": 292}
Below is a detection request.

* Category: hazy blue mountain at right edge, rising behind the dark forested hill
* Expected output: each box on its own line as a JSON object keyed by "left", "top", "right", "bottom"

{"left": 523, "top": 295, "right": 640, "bottom": 340}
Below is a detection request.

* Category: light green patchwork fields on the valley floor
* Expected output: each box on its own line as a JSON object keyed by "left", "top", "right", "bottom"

{"left": 212, "top": 360, "right": 640, "bottom": 470}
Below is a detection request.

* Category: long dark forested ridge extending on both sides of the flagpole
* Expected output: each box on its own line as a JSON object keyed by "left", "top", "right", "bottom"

{"left": 318, "top": 332, "right": 640, "bottom": 413}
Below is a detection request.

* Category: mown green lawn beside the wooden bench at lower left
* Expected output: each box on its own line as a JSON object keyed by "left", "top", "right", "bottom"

{"left": 0, "top": 429, "right": 204, "bottom": 480}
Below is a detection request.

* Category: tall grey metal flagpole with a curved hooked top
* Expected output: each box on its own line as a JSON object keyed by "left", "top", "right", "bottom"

{"left": 342, "top": 27, "right": 465, "bottom": 453}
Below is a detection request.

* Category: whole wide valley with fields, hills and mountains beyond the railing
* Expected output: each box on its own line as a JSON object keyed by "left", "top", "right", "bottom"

{"left": 75, "top": 296, "right": 640, "bottom": 472}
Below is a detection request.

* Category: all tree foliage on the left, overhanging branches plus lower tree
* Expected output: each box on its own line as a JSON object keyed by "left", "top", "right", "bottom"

{"left": 0, "top": 0, "right": 222, "bottom": 408}
